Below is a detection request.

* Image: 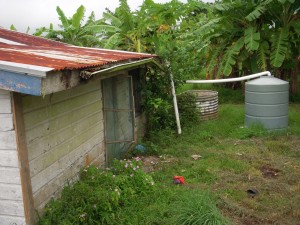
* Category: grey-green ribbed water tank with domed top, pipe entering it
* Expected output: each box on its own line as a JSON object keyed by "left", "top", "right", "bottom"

{"left": 245, "top": 76, "right": 289, "bottom": 130}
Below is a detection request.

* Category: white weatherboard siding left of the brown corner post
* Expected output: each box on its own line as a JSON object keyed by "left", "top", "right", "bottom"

{"left": 0, "top": 90, "right": 25, "bottom": 225}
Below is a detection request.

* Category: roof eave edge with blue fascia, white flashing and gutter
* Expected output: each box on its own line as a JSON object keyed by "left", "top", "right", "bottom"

{"left": 0, "top": 57, "right": 163, "bottom": 96}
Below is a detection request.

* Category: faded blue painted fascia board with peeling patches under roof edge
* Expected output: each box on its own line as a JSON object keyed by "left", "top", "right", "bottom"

{"left": 0, "top": 70, "right": 42, "bottom": 96}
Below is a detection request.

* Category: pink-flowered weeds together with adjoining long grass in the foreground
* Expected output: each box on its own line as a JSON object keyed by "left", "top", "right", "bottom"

{"left": 39, "top": 158, "right": 224, "bottom": 225}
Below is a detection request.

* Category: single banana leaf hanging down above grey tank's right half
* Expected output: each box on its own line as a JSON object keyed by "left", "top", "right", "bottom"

{"left": 270, "top": 28, "right": 289, "bottom": 67}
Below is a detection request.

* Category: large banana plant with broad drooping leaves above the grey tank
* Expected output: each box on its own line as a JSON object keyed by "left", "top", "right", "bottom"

{"left": 196, "top": 0, "right": 300, "bottom": 81}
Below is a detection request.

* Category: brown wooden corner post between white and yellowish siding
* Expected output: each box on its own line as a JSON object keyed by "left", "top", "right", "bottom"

{"left": 12, "top": 92, "right": 36, "bottom": 225}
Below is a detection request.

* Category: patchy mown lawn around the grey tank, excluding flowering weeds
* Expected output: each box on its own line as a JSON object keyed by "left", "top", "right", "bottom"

{"left": 147, "top": 104, "right": 300, "bottom": 225}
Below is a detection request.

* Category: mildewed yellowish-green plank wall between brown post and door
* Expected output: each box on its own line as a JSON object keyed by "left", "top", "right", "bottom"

{"left": 23, "top": 81, "right": 105, "bottom": 211}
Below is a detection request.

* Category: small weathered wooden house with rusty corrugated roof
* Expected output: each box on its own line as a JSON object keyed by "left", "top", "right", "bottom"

{"left": 0, "top": 28, "right": 156, "bottom": 225}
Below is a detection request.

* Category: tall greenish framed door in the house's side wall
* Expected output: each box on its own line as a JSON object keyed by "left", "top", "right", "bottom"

{"left": 102, "top": 75, "right": 135, "bottom": 165}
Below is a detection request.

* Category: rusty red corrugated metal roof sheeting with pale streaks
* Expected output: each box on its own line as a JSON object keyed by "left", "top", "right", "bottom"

{"left": 0, "top": 28, "right": 156, "bottom": 70}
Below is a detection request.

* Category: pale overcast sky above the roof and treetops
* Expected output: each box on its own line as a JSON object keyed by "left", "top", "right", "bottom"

{"left": 0, "top": 0, "right": 214, "bottom": 33}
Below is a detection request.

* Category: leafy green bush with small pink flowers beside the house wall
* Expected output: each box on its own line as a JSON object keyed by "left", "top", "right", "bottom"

{"left": 39, "top": 158, "right": 154, "bottom": 225}
